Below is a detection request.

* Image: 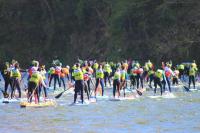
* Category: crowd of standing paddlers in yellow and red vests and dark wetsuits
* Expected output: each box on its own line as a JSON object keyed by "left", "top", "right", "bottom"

{"left": 1, "top": 60, "right": 198, "bottom": 103}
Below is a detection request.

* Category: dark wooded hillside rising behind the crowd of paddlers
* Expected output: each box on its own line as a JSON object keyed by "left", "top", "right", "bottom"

{"left": 0, "top": 0, "right": 200, "bottom": 65}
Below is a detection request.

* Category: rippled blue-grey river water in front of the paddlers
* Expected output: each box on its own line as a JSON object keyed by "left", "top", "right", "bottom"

{"left": 0, "top": 77, "right": 200, "bottom": 133}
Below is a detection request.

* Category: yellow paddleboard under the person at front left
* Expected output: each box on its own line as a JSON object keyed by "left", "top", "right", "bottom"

{"left": 20, "top": 100, "right": 56, "bottom": 107}
